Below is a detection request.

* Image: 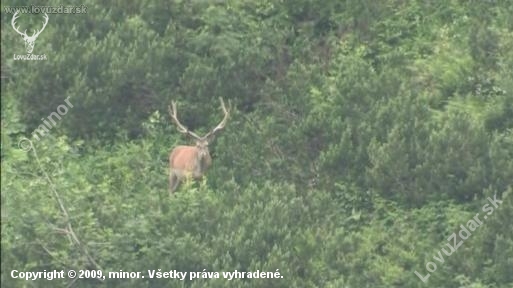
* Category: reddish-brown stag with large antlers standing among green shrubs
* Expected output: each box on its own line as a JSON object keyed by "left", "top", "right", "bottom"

{"left": 168, "top": 98, "right": 231, "bottom": 194}
